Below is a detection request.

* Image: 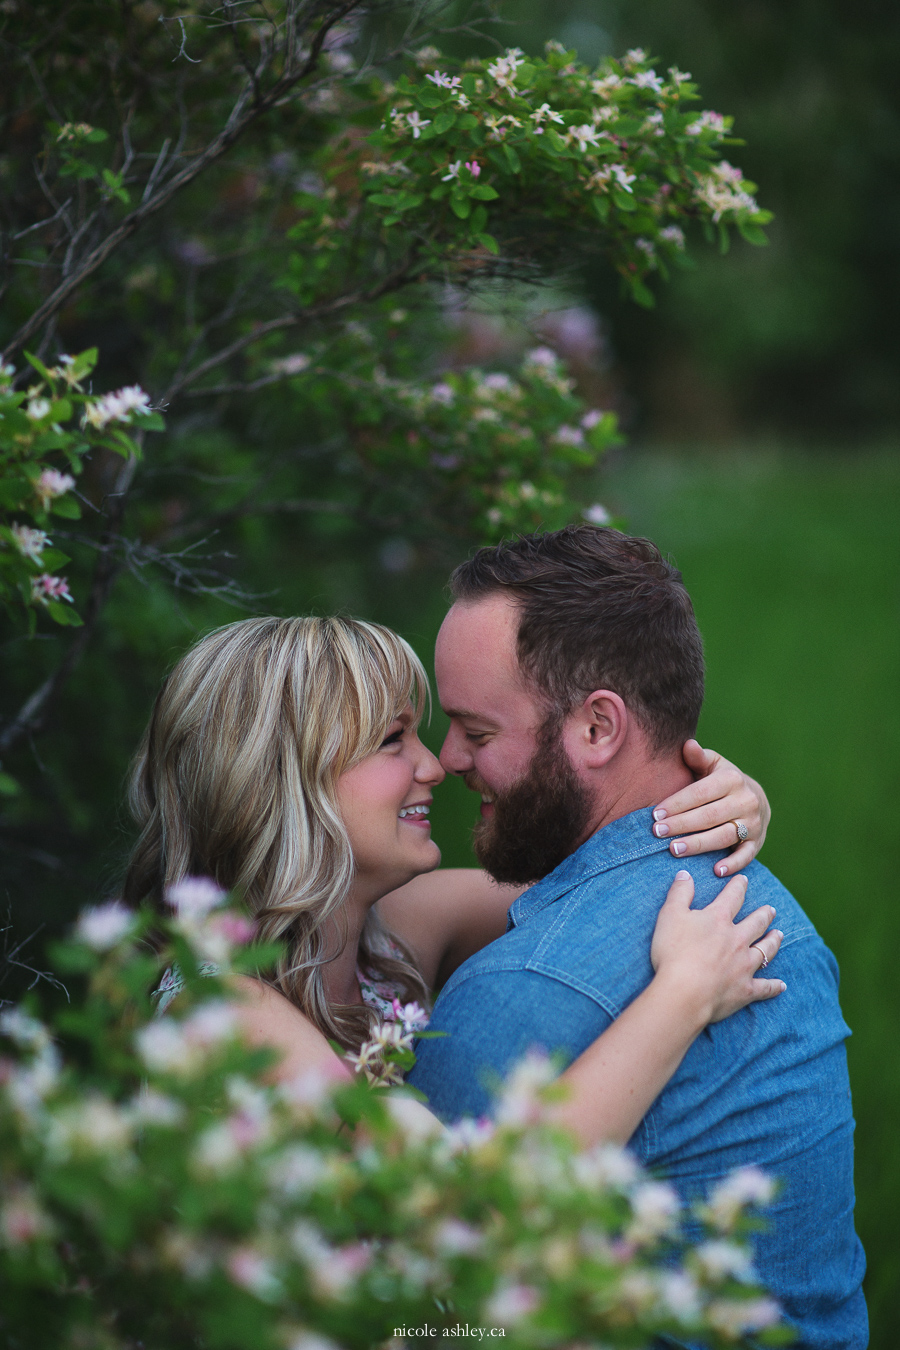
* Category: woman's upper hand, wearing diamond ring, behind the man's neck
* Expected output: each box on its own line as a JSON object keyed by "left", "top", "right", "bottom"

{"left": 653, "top": 741, "right": 772, "bottom": 876}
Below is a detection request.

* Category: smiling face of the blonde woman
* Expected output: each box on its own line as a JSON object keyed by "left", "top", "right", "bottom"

{"left": 337, "top": 706, "right": 444, "bottom": 902}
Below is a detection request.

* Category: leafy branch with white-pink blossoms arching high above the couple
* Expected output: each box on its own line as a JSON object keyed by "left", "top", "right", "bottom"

{"left": 363, "top": 42, "right": 772, "bottom": 305}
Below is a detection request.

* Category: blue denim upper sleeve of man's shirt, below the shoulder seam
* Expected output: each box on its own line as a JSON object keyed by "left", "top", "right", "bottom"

{"left": 407, "top": 969, "right": 613, "bottom": 1121}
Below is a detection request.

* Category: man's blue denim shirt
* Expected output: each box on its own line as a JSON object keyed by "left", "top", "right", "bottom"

{"left": 409, "top": 810, "right": 868, "bottom": 1350}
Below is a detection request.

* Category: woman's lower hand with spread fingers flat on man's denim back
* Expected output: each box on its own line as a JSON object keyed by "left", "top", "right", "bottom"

{"left": 650, "top": 872, "right": 785, "bottom": 1026}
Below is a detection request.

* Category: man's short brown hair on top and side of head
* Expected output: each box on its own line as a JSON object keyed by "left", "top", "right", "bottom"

{"left": 449, "top": 525, "right": 703, "bottom": 752}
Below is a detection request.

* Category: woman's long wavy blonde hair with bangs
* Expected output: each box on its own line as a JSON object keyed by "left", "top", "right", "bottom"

{"left": 124, "top": 618, "right": 428, "bottom": 1049}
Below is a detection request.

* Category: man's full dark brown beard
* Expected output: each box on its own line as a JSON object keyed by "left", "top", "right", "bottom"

{"left": 467, "top": 720, "right": 591, "bottom": 883}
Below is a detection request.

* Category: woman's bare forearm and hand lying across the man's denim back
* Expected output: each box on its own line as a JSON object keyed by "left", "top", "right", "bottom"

{"left": 549, "top": 872, "right": 785, "bottom": 1146}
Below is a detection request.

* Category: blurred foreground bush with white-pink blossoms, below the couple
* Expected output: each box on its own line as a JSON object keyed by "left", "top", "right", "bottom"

{"left": 0, "top": 883, "right": 785, "bottom": 1350}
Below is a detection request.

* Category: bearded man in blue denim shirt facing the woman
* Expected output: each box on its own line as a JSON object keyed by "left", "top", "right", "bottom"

{"left": 410, "top": 525, "right": 868, "bottom": 1350}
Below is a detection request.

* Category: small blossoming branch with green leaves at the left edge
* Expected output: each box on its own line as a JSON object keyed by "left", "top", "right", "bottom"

{"left": 0, "top": 348, "right": 163, "bottom": 632}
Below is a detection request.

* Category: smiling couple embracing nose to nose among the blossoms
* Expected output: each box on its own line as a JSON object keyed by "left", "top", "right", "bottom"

{"left": 125, "top": 525, "right": 868, "bottom": 1350}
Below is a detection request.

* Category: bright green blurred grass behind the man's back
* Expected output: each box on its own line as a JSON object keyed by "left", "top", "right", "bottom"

{"left": 396, "top": 450, "right": 900, "bottom": 1350}
